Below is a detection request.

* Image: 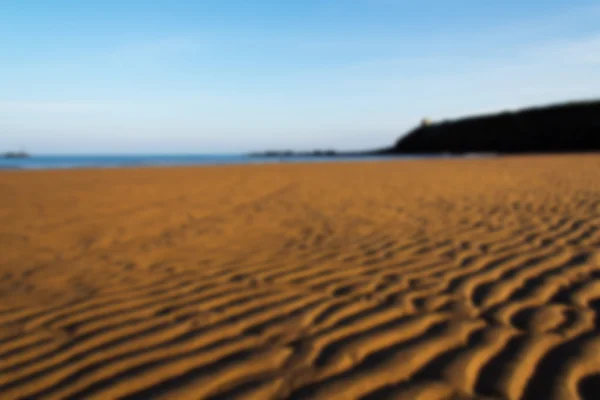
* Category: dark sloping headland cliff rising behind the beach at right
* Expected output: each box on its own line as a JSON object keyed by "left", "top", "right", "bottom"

{"left": 378, "top": 101, "right": 600, "bottom": 155}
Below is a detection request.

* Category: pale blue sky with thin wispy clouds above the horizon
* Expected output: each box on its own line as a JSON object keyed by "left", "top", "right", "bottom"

{"left": 0, "top": 0, "right": 600, "bottom": 154}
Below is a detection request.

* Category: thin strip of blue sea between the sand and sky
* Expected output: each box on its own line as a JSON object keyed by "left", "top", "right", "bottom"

{"left": 0, "top": 154, "right": 404, "bottom": 169}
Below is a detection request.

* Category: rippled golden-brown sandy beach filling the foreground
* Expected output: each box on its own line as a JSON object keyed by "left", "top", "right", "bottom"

{"left": 0, "top": 155, "right": 600, "bottom": 400}
